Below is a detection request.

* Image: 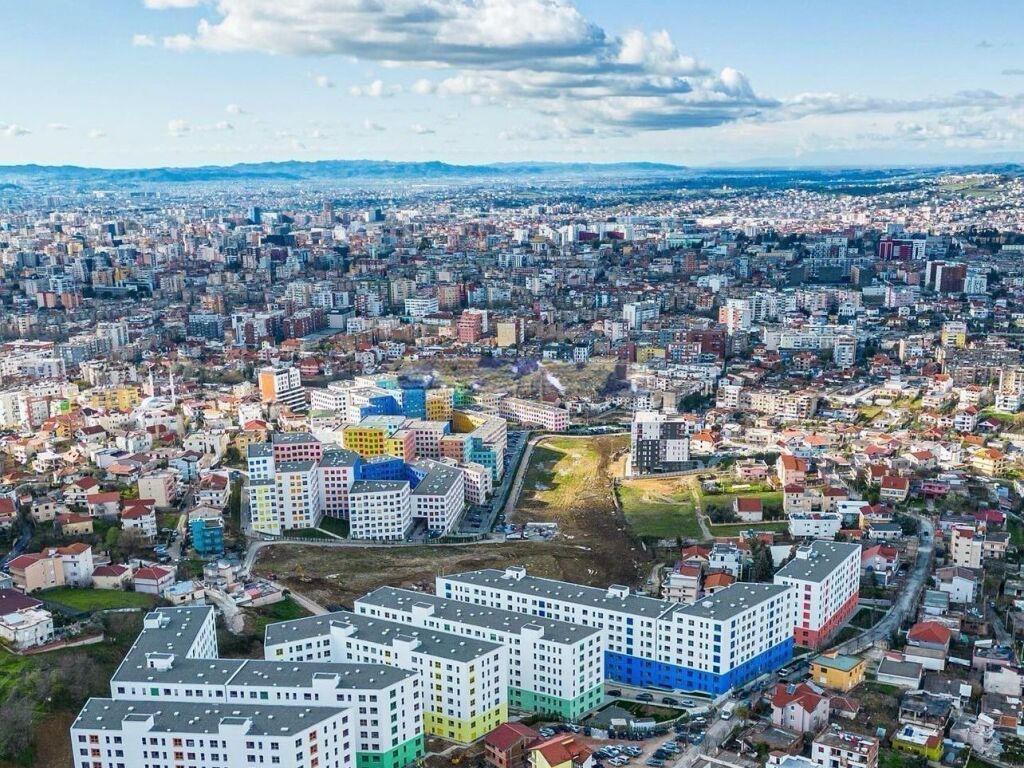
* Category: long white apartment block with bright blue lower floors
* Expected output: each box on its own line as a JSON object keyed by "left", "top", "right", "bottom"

{"left": 435, "top": 566, "right": 795, "bottom": 694}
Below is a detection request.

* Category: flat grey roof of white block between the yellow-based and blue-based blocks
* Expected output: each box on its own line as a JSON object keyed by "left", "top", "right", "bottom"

{"left": 355, "top": 587, "right": 601, "bottom": 645}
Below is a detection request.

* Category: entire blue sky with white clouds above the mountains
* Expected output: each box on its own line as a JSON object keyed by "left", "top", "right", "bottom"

{"left": 6, "top": 0, "right": 1024, "bottom": 168}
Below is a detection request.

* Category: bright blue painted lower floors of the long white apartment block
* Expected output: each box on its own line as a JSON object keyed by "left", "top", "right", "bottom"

{"left": 604, "top": 638, "right": 793, "bottom": 695}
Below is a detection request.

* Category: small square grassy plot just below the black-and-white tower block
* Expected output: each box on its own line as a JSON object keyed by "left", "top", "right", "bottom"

{"left": 618, "top": 477, "right": 703, "bottom": 539}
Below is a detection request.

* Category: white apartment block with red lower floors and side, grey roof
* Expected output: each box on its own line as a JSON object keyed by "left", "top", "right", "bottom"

{"left": 774, "top": 541, "right": 860, "bottom": 648}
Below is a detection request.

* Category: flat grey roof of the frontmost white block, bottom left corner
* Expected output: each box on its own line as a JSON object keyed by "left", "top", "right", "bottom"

{"left": 72, "top": 698, "right": 342, "bottom": 736}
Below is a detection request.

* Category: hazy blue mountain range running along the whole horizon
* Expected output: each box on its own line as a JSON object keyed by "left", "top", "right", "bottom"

{"left": 0, "top": 160, "right": 1024, "bottom": 188}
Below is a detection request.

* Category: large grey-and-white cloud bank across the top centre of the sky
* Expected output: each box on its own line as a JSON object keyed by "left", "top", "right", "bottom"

{"left": 142, "top": 0, "right": 776, "bottom": 129}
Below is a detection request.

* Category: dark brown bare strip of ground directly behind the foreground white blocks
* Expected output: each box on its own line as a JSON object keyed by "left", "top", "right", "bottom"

{"left": 255, "top": 539, "right": 646, "bottom": 607}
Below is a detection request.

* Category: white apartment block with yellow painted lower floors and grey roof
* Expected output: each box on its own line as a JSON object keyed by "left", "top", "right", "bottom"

{"left": 264, "top": 611, "right": 508, "bottom": 742}
